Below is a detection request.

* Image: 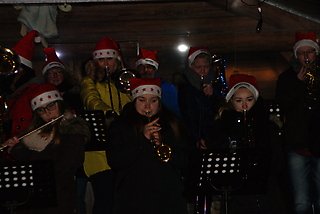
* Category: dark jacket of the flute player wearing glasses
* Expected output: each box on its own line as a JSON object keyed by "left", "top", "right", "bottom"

{"left": 11, "top": 118, "right": 90, "bottom": 214}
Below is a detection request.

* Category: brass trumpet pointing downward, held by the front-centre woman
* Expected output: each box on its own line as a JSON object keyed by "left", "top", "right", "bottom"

{"left": 145, "top": 111, "right": 172, "bottom": 163}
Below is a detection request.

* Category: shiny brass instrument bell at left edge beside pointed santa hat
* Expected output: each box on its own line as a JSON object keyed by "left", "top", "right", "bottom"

{"left": 0, "top": 46, "right": 20, "bottom": 75}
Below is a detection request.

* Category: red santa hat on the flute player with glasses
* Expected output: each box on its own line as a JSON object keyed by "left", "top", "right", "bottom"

{"left": 30, "top": 83, "right": 63, "bottom": 110}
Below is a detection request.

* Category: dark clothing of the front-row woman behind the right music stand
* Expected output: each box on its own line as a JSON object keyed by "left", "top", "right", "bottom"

{"left": 207, "top": 98, "right": 271, "bottom": 196}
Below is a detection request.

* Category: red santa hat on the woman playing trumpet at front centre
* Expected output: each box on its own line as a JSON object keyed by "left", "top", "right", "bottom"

{"left": 129, "top": 78, "right": 161, "bottom": 99}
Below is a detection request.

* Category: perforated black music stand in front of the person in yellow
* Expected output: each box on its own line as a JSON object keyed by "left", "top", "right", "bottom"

{"left": 80, "top": 110, "right": 107, "bottom": 151}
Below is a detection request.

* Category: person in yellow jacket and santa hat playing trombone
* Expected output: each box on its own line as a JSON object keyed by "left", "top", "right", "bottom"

{"left": 80, "top": 37, "right": 131, "bottom": 214}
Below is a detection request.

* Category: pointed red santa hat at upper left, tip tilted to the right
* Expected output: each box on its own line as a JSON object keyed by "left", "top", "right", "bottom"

{"left": 12, "top": 30, "right": 40, "bottom": 68}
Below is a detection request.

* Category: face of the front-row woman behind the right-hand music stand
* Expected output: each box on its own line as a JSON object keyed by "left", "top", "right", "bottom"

{"left": 231, "top": 87, "right": 256, "bottom": 112}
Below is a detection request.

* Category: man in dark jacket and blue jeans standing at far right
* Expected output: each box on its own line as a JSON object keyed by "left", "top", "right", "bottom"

{"left": 276, "top": 32, "right": 320, "bottom": 213}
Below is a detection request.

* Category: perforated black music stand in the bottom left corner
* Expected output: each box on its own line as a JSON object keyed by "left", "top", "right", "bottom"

{"left": 0, "top": 161, "right": 57, "bottom": 214}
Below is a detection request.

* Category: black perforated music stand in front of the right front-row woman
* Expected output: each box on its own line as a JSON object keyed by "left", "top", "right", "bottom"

{"left": 198, "top": 151, "right": 244, "bottom": 214}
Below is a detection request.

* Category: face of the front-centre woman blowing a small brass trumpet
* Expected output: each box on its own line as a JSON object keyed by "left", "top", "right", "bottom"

{"left": 135, "top": 94, "right": 160, "bottom": 117}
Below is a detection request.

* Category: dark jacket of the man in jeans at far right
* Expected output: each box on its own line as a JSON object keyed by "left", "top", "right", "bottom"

{"left": 276, "top": 68, "right": 320, "bottom": 155}
